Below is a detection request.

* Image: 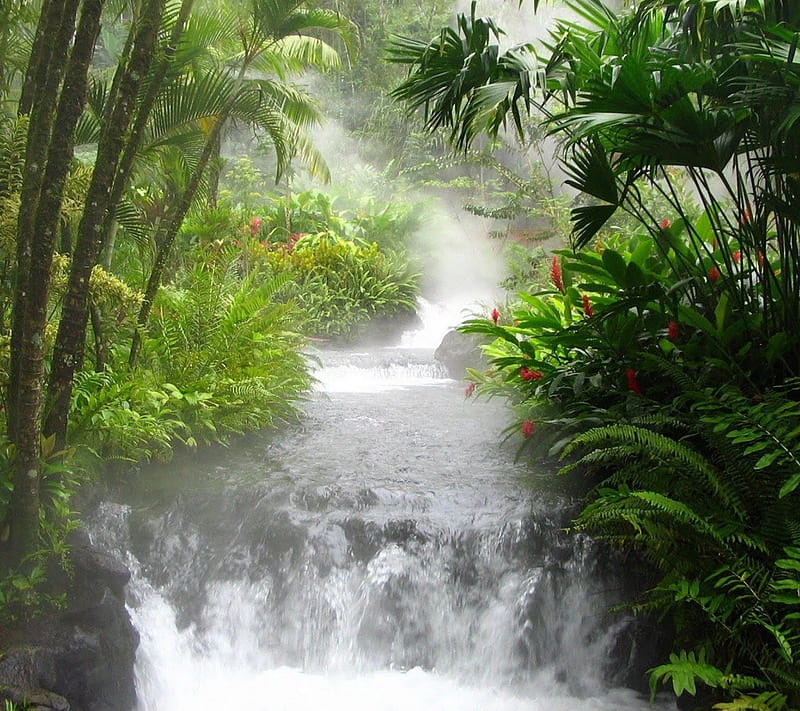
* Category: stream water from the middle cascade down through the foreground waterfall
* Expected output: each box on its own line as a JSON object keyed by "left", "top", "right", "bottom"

{"left": 90, "top": 326, "right": 674, "bottom": 711}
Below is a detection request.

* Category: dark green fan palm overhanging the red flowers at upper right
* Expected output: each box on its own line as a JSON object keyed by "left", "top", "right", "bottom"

{"left": 390, "top": 0, "right": 800, "bottom": 380}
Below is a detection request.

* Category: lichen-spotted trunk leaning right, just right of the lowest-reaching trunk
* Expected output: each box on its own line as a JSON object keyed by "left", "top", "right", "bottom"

{"left": 44, "top": 0, "right": 165, "bottom": 449}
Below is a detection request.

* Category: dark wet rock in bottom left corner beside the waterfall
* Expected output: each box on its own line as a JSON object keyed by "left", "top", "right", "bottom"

{"left": 0, "top": 535, "right": 139, "bottom": 711}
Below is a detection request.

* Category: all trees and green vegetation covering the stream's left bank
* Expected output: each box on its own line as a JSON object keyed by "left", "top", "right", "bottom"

{"left": 0, "top": 0, "right": 417, "bottom": 621}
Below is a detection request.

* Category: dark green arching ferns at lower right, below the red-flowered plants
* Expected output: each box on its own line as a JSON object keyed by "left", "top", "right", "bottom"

{"left": 564, "top": 383, "right": 800, "bottom": 709}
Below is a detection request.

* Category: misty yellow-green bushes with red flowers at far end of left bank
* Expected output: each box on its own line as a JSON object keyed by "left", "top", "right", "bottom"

{"left": 184, "top": 190, "right": 419, "bottom": 339}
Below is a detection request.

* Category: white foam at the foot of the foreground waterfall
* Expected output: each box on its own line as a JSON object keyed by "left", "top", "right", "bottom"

{"left": 133, "top": 584, "right": 675, "bottom": 711}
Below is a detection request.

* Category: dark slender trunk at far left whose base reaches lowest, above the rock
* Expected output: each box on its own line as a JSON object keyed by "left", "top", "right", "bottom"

{"left": 9, "top": 0, "right": 104, "bottom": 560}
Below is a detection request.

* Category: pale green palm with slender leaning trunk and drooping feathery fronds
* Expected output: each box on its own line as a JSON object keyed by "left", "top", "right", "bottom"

{"left": 129, "top": 0, "right": 353, "bottom": 367}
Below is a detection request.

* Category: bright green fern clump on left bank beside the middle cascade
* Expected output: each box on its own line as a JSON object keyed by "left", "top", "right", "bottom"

{"left": 142, "top": 250, "right": 310, "bottom": 444}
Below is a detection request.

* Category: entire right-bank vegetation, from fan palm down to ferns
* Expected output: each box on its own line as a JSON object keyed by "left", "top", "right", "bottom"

{"left": 392, "top": 0, "right": 800, "bottom": 711}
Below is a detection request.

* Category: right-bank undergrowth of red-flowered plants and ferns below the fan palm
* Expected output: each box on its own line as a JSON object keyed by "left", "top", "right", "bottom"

{"left": 461, "top": 229, "right": 800, "bottom": 709}
